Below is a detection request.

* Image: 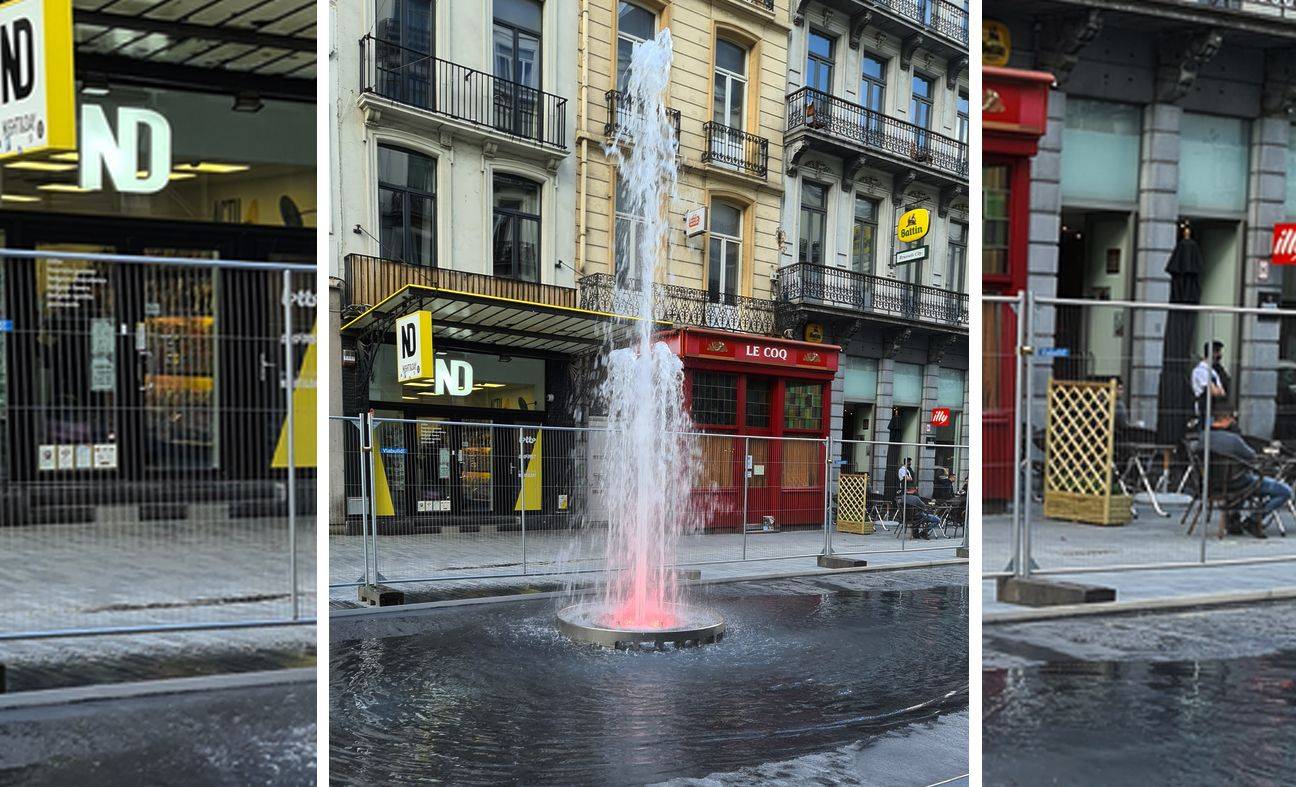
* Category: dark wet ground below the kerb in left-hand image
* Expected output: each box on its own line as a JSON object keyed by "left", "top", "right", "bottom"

{"left": 0, "top": 682, "right": 316, "bottom": 787}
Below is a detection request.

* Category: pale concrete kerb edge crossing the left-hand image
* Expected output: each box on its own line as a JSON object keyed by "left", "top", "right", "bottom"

{"left": 0, "top": 666, "right": 318, "bottom": 712}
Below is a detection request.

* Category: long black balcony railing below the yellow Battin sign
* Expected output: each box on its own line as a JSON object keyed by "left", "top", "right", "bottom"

{"left": 779, "top": 262, "right": 968, "bottom": 329}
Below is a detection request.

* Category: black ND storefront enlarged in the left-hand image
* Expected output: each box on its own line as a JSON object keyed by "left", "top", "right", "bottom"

{"left": 0, "top": 0, "right": 316, "bottom": 517}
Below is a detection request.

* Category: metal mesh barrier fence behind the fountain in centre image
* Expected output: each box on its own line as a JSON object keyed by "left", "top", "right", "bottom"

{"left": 329, "top": 415, "right": 967, "bottom": 589}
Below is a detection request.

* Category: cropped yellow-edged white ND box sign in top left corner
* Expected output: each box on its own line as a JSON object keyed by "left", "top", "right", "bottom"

{"left": 0, "top": 0, "right": 76, "bottom": 158}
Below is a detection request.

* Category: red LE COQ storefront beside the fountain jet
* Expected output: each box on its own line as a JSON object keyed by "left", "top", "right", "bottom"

{"left": 662, "top": 328, "right": 841, "bottom": 529}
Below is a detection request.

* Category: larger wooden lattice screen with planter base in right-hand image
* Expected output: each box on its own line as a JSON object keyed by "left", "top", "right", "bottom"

{"left": 1045, "top": 380, "right": 1130, "bottom": 525}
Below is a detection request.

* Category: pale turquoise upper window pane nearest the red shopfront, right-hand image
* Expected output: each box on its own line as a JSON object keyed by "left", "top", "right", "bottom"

{"left": 1061, "top": 99, "right": 1145, "bottom": 205}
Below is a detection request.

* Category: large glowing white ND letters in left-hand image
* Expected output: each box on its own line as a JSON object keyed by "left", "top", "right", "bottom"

{"left": 79, "top": 104, "right": 171, "bottom": 194}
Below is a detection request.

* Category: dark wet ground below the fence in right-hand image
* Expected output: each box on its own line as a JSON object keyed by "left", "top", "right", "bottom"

{"left": 982, "top": 603, "right": 1296, "bottom": 786}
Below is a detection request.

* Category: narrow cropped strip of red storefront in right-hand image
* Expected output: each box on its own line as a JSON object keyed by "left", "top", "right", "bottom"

{"left": 981, "top": 66, "right": 1054, "bottom": 500}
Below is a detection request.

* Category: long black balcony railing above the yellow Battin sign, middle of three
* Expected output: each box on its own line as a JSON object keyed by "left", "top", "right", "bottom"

{"left": 788, "top": 87, "right": 968, "bottom": 179}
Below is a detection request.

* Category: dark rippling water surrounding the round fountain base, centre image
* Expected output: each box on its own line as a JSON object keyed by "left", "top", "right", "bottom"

{"left": 329, "top": 574, "right": 968, "bottom": 784}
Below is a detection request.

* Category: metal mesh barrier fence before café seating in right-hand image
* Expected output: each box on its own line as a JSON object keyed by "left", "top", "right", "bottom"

{"left": 982, "top": 293, "right": 1296, "bottom": 577}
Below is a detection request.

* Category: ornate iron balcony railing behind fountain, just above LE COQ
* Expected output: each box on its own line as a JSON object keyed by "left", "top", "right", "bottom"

{"left": 581, "top": 274, "right": 775, "bottom": 336}
